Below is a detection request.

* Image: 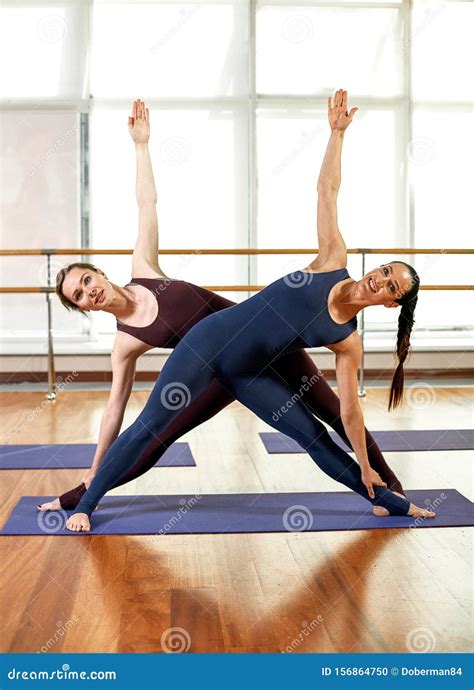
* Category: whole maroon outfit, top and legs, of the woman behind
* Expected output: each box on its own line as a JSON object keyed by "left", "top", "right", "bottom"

{"left": 59, "top": 278, "right": 404, "bottom": 510}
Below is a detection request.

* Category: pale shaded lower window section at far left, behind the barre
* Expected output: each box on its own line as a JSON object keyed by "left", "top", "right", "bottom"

{"left": 0, "top": 108, "right": 83, "bottom": 338}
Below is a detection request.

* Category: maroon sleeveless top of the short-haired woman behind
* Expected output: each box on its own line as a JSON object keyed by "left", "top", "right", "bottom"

{"left": 117, "top": 278, "right": 235, "bottom": 348}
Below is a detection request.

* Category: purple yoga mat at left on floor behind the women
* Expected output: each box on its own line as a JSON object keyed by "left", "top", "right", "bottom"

{"left": 0, "top": 443, "right": 196, "bottom": 470}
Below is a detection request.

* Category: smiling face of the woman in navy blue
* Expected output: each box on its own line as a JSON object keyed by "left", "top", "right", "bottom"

{"left": 358, "top": 262, "right": 413, "bottom": 307}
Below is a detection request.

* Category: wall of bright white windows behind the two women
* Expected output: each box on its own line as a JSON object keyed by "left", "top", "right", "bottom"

{"left": 0, "top": 0, "right": 474, "bottom": 338}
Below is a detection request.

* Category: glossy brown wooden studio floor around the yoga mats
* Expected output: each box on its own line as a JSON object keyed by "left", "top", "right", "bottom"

{"left": 0, "top": 383, "right": 474, "bottom": 653}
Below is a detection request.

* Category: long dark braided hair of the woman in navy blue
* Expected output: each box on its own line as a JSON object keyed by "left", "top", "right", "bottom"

{"left": 388, "top": 261, "right": 420, "bottom": 410}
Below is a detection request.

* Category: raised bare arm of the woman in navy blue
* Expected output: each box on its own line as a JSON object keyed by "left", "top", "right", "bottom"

{"left": 308, "top": 89, "right": 357, "bottom": 271}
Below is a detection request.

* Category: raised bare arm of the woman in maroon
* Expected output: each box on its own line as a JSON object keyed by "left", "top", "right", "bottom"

{"left": 128, "top": 100, "right": 164, "bottom": 278}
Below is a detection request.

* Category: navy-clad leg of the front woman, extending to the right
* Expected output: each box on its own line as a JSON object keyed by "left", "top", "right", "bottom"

{"left": 225, "top": 370, "right": 410, "bottom": 515}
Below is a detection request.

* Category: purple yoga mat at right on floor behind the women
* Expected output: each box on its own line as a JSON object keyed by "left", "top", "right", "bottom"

{"left": 260, "top": 429, "right": 474, "bottom": 453}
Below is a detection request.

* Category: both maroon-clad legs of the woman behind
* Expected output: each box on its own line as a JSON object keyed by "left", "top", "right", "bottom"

{"left": 59, "top": 350, "right": 404, "bottom": 510}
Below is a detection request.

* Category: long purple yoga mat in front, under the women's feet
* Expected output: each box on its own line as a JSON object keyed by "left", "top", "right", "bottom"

{"left": 3, "top": 489, "right": 474, "bottom": 536}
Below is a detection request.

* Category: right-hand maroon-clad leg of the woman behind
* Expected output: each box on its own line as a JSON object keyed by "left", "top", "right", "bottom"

{"left": 272, "top": 350, "right": 405, "bottom": 494}
